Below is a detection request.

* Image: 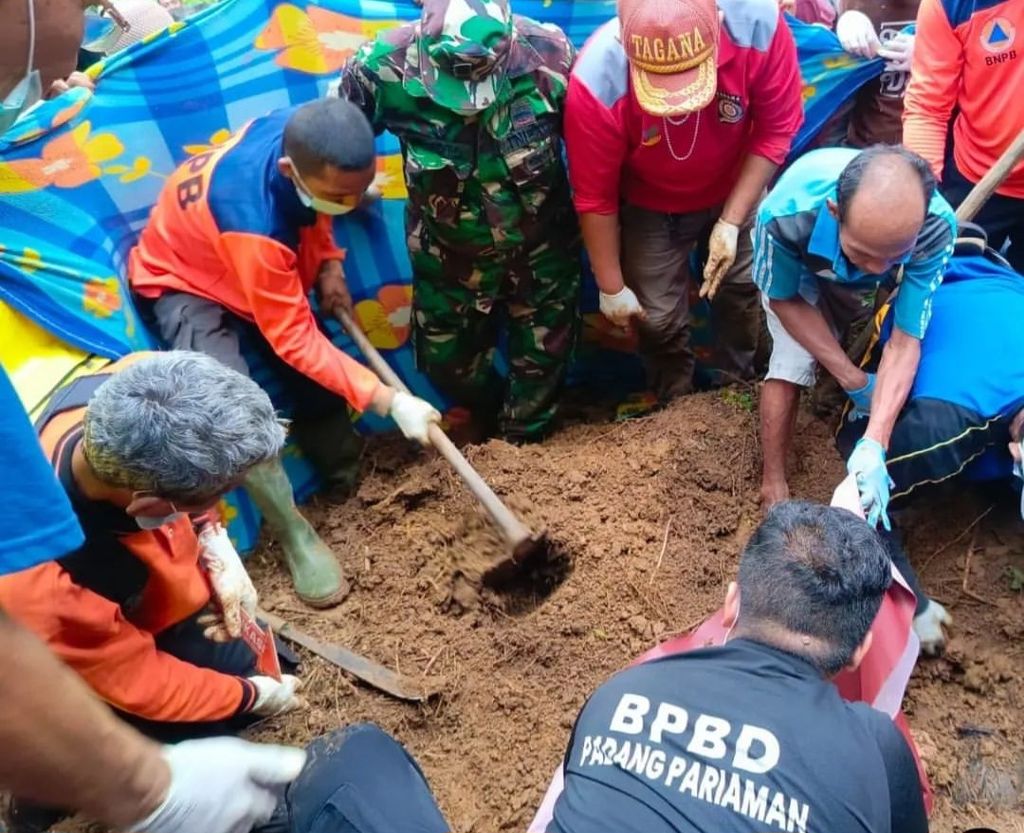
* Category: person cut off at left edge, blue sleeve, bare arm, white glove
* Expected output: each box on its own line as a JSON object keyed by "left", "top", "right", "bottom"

{"left": 0, "top": 358, "right": 305, "bottom": 833}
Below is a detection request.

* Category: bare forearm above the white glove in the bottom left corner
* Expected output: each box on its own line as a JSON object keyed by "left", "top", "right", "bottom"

{"left": 0, "top": 613, "right": 171, "bottom": 826}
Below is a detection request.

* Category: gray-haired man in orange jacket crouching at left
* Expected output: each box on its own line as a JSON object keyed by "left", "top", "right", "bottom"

{"left": 0, "top": 350, "right": 301, "bottom": 741}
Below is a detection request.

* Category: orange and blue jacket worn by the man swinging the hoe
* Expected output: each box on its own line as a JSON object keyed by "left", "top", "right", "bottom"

{"left": 128, "top": 109, "right": 379, "bottom": 411}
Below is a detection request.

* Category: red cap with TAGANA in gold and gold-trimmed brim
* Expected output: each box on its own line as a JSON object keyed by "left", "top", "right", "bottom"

{"left": 618, "top": 0, "right": 719, "bottom": 116}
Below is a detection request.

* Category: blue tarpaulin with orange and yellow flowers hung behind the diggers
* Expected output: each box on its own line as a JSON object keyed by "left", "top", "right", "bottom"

{"left": 0, "top": 0, "right": 882, "bottom": 547}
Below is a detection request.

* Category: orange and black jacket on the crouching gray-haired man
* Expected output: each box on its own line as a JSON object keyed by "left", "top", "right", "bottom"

{"left": 0, "top": 353, "right": 256, "bottom": 722}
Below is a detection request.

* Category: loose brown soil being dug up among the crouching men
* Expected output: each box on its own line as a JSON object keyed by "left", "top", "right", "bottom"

{"left": 241, "top": 392, "right": 1024, "bottom": 833}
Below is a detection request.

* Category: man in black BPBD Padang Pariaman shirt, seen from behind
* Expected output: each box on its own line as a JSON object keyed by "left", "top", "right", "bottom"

{"left": 547, "top": 501, "right": 928, "bottom": 833}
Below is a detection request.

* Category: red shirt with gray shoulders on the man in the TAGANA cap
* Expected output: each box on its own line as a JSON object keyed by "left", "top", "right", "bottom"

{"left": 565, "top": 7, "right": 804, "bottom": 214}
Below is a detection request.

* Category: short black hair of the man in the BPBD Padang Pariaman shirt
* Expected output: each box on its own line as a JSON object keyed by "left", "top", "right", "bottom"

{"left": 739, "top": 500, "right": 892, "bottom": 676}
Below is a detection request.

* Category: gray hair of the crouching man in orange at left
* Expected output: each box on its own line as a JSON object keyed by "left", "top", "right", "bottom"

{"left": 83, "top": 350, "right": 285, "bottom": 504}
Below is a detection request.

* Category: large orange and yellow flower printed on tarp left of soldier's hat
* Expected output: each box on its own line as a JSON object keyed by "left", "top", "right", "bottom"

{"left": 254, "top": 3, "right": 385, "bottom": 75}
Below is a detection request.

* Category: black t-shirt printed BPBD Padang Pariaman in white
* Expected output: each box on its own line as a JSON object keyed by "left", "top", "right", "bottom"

{"left": 548, "top": 639, "right": 928, "bottom": 833}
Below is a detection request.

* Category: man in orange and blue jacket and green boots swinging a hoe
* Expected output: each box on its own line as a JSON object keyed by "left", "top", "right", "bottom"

{"left": 128, "top": 99, "right": 440, "bottom": 608}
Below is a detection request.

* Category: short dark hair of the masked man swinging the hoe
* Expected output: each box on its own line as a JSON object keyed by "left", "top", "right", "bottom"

{"left": 285, "top": 98, "right": 376, "bottom": 174}
